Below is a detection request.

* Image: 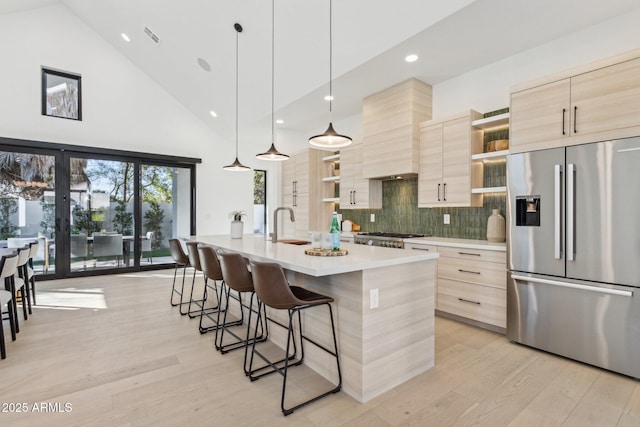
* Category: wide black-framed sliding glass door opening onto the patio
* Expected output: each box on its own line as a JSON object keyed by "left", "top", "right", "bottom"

{"left": 0, "top": 138, "right": 197, "bottom": 278}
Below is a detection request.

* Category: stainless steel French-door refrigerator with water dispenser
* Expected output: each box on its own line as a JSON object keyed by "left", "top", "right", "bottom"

{"left": 507, "top": 137, "right": 640, "bottom": 378}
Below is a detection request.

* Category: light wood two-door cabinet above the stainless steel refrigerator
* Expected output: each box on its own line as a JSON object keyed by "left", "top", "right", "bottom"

{"left": 510, "top": 51, "right": 640, "bottom": 153}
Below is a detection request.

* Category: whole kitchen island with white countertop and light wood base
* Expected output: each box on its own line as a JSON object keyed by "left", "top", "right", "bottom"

{"left": 191, "top": 235, "right": 438, "bottom": 402}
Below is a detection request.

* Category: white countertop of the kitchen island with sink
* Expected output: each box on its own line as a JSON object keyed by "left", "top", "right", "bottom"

{"left": 191, "top": 234, "right": 438, "bottom": 277}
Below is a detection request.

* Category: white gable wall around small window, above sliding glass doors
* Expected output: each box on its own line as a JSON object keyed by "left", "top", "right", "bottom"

{"left": 0, "top": 5, "right": 279, "bottom": 234}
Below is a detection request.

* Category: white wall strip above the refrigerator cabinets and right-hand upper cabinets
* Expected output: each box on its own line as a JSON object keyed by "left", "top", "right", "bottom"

{"left": 433, "top": 10, "right": 640, "bottom": 119}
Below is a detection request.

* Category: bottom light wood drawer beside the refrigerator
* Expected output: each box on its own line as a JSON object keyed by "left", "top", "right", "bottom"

{"left": 437, "top": 277, "right": 507, "bottom": 328}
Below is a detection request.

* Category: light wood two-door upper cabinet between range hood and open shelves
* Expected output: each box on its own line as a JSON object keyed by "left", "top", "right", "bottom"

{"left": 418, "top": 111, "right": 482, "bottom": 208}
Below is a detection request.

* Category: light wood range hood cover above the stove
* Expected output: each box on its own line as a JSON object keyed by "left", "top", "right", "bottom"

{"left": 362, "top": 79, "right": 432, "bottom": 178}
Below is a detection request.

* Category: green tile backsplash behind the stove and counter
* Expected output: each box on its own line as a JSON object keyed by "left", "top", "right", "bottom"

{"left": 339, "top": 177, "right": 506, "bottom": 240}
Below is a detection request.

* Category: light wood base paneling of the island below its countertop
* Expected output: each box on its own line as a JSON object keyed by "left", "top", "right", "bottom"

{"left": 269, "top": 262, "right": 436, "bottom": 402}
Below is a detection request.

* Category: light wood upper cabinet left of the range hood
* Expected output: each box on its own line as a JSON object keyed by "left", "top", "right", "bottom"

{"left": 340, "top": 143, "right": 382, "bottom": 209}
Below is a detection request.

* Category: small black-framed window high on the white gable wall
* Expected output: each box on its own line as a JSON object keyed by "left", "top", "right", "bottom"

{"left": 42, "top": 67, "right": 82, "bottom": 120}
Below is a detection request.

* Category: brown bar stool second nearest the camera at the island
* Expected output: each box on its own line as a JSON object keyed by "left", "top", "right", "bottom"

{"left": 215, "top": 252, "right": 268, "bottom": 375}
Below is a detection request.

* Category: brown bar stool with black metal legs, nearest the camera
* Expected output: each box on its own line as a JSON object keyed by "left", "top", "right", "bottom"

{"left": 249, "top": 261, "right": 342, "bottom": 416}
